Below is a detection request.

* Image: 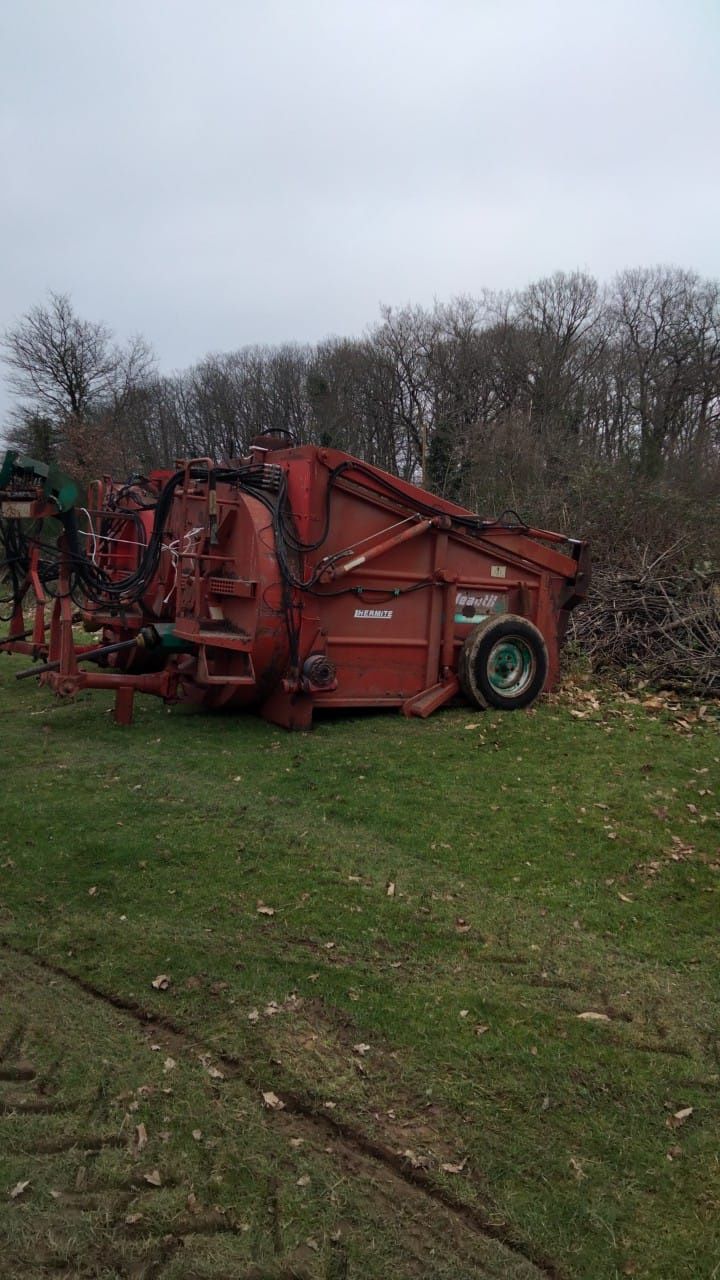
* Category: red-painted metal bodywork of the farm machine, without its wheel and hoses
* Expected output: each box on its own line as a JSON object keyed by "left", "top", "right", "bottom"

{"left": 6, "top": 445, "right": 587, "bottom": 728}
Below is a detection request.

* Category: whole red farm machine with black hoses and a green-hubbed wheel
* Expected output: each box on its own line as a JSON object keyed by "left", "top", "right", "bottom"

{"left": 0, "top": 436, "right": 588, "bottom": 728}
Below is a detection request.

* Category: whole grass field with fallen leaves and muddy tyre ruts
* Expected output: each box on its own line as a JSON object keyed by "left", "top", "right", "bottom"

{"left": 0, "top": 658, "right": 720, "bottom": 1280}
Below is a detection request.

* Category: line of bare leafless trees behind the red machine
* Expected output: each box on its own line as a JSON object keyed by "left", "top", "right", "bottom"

{"left": 3, "top": 268, "right": 720, "bottom": 558}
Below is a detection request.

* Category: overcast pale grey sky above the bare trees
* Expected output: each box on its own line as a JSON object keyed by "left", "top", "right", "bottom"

{"left": 0, "top": 0, "right": 720, "bottom": 422}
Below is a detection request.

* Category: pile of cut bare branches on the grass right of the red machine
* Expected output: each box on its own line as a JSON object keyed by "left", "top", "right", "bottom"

{"left": 568, "top": 557, "right": 720, "bottom": 696}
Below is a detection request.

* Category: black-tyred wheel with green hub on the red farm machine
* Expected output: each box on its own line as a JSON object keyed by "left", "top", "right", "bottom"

{"left": 457, "top": 613, "right": 548, "bottom": 712}
